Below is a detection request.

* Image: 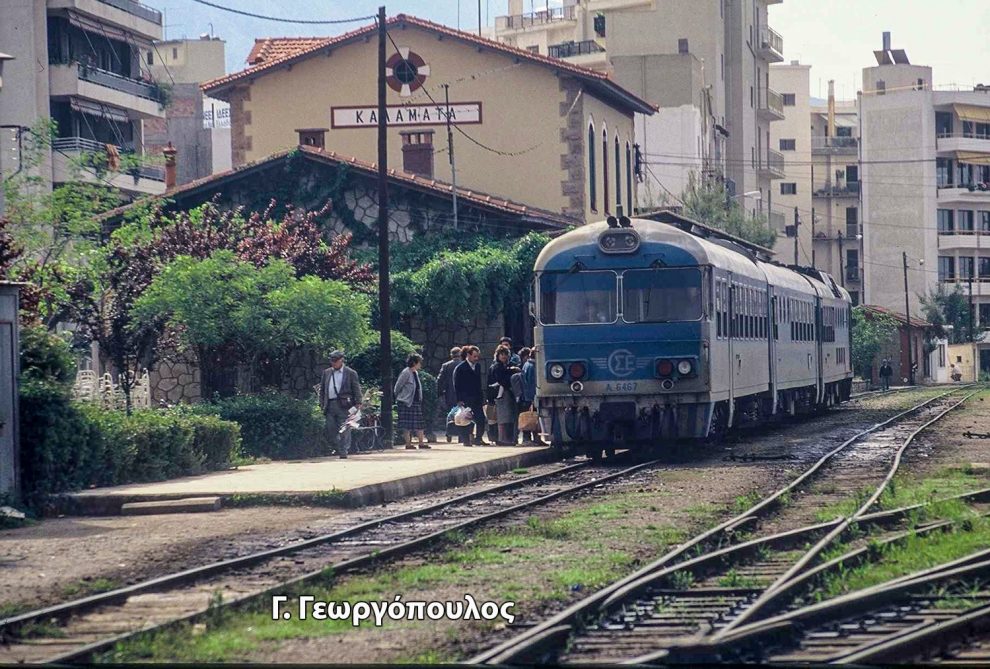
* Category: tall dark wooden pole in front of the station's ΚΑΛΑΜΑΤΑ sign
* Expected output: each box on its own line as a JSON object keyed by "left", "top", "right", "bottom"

{"left": 378, "top": 5, "right": 392, "bottom": 448}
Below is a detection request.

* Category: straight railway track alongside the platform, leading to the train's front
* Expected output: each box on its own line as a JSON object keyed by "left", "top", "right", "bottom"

{"left": 0, "top": 460, "right": 658, "bottom": 664}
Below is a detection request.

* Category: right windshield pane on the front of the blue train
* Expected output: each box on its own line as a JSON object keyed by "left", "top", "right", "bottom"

{"left": 622, "top": 269, "right": 704, "bottom": 323}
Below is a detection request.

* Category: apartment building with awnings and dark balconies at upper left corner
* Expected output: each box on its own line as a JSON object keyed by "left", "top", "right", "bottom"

{"left": 0, "top": 0, "right": 168, "bottom": 196}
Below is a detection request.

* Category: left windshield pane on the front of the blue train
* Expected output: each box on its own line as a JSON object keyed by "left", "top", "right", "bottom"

{"left": 540, "top": 272, "right": 619, "bottom": 325}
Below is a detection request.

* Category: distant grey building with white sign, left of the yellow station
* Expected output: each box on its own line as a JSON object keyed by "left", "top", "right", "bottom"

{"left": 144, "top": 34, "right": 231, "bottom": 186}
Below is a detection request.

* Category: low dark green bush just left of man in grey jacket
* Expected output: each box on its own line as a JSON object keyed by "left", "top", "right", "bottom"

{"left": 187, "top": 392, "right": 325, "bottom": 459}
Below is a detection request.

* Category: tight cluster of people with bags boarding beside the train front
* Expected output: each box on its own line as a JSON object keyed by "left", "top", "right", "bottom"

{"left": 437, "top": 337, "right": 544, "bottom": 446}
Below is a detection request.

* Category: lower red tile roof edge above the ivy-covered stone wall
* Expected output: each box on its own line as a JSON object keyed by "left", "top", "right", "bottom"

{"left": 99, "top": 146, "right": 581, "bottom": 228}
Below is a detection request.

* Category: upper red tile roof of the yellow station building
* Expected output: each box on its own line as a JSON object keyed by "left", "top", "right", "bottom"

{"left": 200, "top": 14, "right": 657, "bottom": 114}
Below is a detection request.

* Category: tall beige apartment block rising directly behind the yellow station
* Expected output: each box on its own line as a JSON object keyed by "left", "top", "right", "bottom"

{"left": 491, "top": 0, "right": 784, "bottom": 215}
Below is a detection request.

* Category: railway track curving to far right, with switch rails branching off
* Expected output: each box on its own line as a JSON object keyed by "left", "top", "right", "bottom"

{"left": 470, "top": 388, "right": 975, "bottom": 664}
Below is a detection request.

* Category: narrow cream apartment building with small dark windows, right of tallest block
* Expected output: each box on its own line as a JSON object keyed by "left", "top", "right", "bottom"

{"left": 766, "top": 61, "right": 821, "bottom": 266}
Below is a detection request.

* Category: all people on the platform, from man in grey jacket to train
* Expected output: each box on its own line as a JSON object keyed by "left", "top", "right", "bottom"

{"left": 320, "top": 337, "right": 545, "bottom": 458}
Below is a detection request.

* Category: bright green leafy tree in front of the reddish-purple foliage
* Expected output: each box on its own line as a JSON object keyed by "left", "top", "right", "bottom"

{"left": 133, "top": 250, "right": 371, "bottom": 396}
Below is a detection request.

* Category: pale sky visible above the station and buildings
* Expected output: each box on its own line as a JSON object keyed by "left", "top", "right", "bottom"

{"left": 144, "top": 0, "right": 990, "bottom": 99}
